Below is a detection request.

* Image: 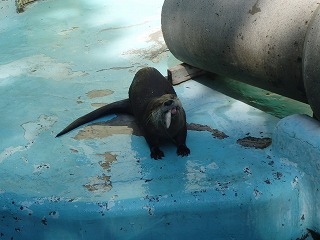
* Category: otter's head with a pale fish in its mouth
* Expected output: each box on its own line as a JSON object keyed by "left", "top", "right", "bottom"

{"left": 149, "top": 94, "right": 182, "bottom": 129}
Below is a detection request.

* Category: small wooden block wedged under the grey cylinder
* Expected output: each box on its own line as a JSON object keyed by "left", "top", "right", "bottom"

{"left": 168, "top": 63, "right": 207, "bottom": 85}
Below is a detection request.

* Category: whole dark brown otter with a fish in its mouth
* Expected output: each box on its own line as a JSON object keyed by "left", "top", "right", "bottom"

{"left": 57, "top": 67, "right": 190, "bottom": 159}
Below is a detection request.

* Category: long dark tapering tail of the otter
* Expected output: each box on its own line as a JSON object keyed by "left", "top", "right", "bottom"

{"left": 56, "top": 98, "right": 132, "bottom": 137}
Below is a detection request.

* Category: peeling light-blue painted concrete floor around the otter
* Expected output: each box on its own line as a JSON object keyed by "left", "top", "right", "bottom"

{"left": 0, "top": 0, "right": 319, "bottom": 239}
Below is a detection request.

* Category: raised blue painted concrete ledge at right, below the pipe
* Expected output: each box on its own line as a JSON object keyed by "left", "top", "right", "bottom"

{"left": 272, "top": 114, "right": 320, "bottom": 231}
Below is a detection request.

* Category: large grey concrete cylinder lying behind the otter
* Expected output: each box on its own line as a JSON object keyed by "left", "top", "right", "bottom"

{"left": 161, "top": 0, "right": 320, "bottom": 116}
